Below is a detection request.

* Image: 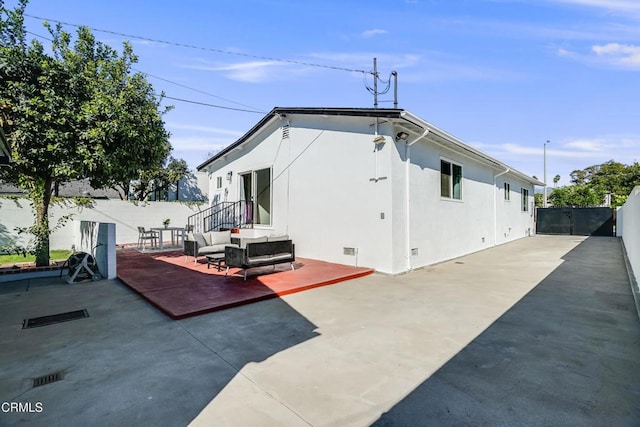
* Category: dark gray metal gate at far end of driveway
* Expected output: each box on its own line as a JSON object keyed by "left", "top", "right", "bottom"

{"left": 536, "top": 208, "right": 615, "bottom": 236}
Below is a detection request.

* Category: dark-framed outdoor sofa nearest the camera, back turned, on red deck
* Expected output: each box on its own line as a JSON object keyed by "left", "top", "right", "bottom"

{"left": 224, "top": 236, "right": 296, "bottom": 280}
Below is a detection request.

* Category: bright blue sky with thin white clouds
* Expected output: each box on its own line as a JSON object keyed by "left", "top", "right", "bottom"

{"left": 5, "top": 0, "right": 640, "bottom": 185}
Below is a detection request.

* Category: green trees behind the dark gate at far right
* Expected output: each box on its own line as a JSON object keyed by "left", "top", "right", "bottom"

{"left": 549, "top": 160, "right": 640, "bottom": 207}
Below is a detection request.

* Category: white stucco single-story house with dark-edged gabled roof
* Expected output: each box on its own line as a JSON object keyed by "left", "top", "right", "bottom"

{"left": 198, "top": 107, "right": 543, "bottom": 274}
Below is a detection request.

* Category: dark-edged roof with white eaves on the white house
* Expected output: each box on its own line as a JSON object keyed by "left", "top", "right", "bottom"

{"left": 197, "top": 107, "right": 544, "bottom": 186}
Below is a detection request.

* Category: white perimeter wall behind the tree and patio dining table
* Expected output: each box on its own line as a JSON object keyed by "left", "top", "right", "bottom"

{"left": 0, "top": 198, "right": 207, "bottom": 249}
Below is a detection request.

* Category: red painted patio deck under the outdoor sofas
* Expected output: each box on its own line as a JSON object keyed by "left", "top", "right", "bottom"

{"left": 117, "top": 249, "right": 373, "bottom": 319}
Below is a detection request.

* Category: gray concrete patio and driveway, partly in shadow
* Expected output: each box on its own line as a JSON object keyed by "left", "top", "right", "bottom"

{"left": 0, "top": 236, "right": 640, "bottom": 426}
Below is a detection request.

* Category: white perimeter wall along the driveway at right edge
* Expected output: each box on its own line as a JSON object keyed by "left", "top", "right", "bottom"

{"left": 616, "top": 185, "right": 640, "bottom": 280}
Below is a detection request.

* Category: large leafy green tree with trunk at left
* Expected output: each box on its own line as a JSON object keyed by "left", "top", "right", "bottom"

{"left": 0, "top": 0, "right": 171, "bottom": 265}
